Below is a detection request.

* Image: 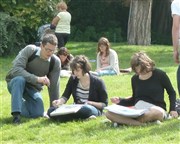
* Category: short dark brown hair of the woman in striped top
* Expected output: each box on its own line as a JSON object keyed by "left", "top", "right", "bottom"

{"left": 70, "top": 55, "right": 91, "bottom": 75}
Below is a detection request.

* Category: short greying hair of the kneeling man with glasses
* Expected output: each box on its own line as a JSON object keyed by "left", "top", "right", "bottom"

{"left": 41, "top": 34, "right": 58, "bottom": 46}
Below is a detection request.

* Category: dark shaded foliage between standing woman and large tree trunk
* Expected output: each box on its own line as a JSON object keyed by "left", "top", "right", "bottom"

{"left": 68, "top": 0, "right": 128, "bottom": 42}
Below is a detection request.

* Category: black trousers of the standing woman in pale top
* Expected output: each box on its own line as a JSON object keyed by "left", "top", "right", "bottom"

{"left": 55, "top": 33, "right": 70, "bottom": 48}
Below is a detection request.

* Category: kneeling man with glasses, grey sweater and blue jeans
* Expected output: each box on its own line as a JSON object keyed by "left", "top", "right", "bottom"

{"left": 6, "top": 34, "right": 61, "bottom": 124}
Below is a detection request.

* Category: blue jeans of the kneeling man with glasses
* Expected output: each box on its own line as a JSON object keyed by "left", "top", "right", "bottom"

{"left": 8, "top": 76, "right": 44, "bottom": 118}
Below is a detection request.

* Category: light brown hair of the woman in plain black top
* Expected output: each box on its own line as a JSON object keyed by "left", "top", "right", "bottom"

{"left": 131, "top": 51, "right": 155, "bottom": 73}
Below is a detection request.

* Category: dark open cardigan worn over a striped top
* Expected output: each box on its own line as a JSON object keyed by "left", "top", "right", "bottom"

{"left": 62, "top": 74, "right": 108, "bottom": 111}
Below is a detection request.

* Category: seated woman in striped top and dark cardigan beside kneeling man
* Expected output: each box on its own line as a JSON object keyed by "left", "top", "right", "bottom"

{"left": 48, "top": 55, "right": 108, "bottom": 122}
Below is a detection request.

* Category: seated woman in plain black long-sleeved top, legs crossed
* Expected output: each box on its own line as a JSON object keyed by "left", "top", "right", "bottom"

{"left": 106, "top": 52, "right": 178, "bottom": 125}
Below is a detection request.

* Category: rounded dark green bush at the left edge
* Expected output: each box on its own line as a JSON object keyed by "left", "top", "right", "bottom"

{"left": 0, "top": 12, "right": 25, "bottom": 56}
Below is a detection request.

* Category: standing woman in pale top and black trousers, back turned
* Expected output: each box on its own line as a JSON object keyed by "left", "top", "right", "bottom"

{"left": 50, "top": 1, "right": 71, "bottom": 48}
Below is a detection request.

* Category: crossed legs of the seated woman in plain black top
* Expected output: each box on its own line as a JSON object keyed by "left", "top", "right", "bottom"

{"left": 105, "top": 106, "right": 166, "bottom": 126}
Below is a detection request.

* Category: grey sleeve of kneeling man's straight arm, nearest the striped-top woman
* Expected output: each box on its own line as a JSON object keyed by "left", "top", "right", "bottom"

{"left": 48, "top": 58, "right": 61, "bottom": 106}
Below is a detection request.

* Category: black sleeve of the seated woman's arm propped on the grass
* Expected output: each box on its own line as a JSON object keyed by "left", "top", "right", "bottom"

{"left": 161, "top": 72, "right": 176, "bottom": 111}
